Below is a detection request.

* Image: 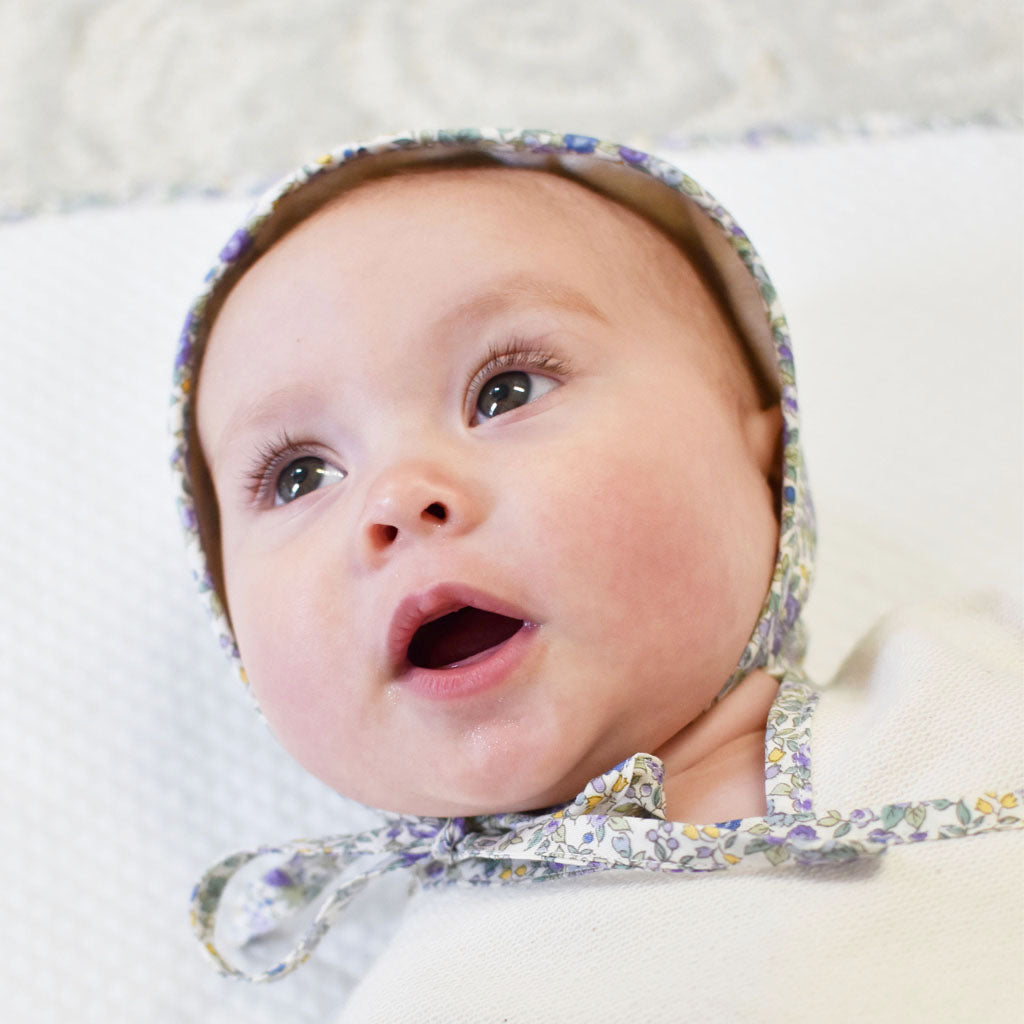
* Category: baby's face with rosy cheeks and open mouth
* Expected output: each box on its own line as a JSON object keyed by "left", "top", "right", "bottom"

{"left": 198, "top": 170, "right": 779, "bottom": 815}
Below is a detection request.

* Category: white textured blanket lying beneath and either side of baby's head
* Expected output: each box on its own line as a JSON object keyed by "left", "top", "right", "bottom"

{"left": 0, "top": 129, "right": 1024, "bottom": 1024}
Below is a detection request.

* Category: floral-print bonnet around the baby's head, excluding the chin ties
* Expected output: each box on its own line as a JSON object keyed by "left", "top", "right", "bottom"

{"left": 171, "top": 129, "right": 814, "bottom": 698}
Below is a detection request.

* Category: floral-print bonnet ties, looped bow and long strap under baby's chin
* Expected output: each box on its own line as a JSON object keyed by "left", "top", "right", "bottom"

{"left": 191, "top": 729, "right": 1024, "bottom": 981}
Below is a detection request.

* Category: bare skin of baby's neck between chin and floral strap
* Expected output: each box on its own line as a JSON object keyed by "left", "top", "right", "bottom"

{"left": 653, "top": 669, "right": 778, "bottom": 824}
